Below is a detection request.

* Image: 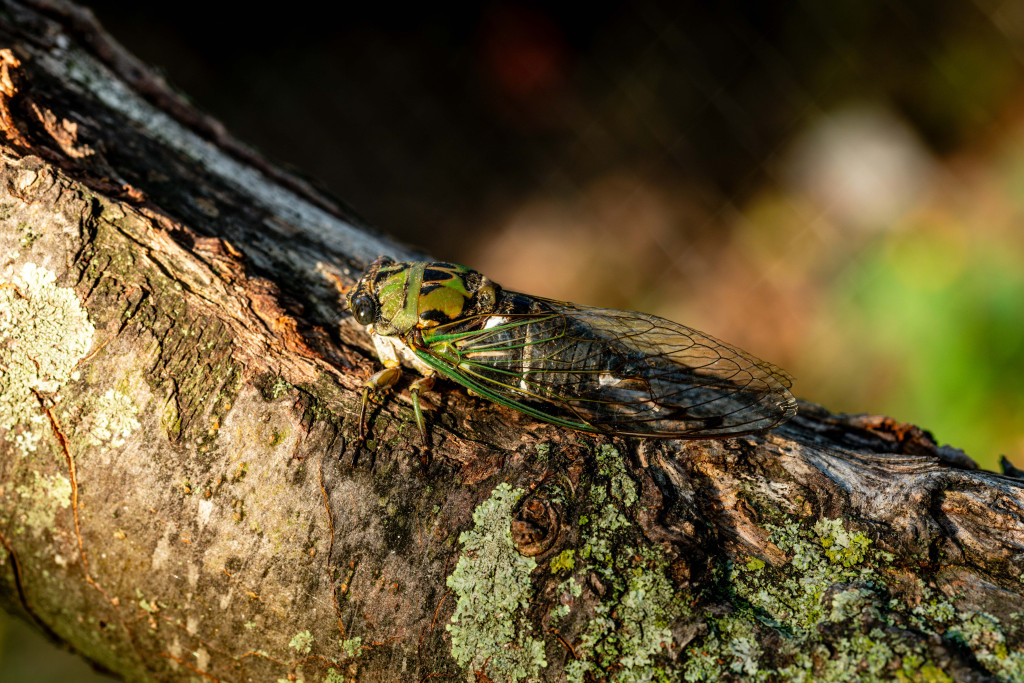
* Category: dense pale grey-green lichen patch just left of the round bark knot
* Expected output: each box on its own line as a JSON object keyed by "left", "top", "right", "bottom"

{"left": 446, "top": 483, "right": 548, "bottom": 683}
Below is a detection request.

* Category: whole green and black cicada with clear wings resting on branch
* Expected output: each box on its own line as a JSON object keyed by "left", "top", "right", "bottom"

{"left": 347, "top": 256, "right": 797, "bottom": 441}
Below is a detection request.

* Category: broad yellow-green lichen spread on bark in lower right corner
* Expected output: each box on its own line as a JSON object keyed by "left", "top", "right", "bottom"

{"left": 684, "top": 519, "right": 1024, "bottom": 683}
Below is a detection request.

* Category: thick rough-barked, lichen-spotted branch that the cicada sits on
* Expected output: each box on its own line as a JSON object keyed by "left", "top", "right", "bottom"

{"left": 0, "top": 0, "right": 1024, "bottom": 681}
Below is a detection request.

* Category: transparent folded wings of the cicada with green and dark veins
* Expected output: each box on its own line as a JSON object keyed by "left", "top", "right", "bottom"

{"left": 419, "top": 295, "right": 797, "bottom": 438}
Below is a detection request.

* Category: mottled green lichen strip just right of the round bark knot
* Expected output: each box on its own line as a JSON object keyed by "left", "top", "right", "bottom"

{"left": 565, "top": 445, "right": 687, "bottom": 683}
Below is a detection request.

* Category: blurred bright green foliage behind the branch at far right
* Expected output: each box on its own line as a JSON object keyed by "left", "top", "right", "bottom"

{"left": 815, "top": 228, "right": 1024, "bottom": 470}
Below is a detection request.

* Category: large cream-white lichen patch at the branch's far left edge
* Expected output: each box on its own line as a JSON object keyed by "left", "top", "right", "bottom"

{"left": 0, "top": 263, "right": 95, "bottom": 455}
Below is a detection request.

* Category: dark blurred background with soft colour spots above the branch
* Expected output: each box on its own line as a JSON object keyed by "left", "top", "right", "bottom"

{"left": 0, "top": 0, "right": 1024, "bottom": 681}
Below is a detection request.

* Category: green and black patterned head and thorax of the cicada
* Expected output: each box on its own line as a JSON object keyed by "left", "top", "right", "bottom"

{"left": 348, "top": 256, "right": 501, "bottom": 337}
